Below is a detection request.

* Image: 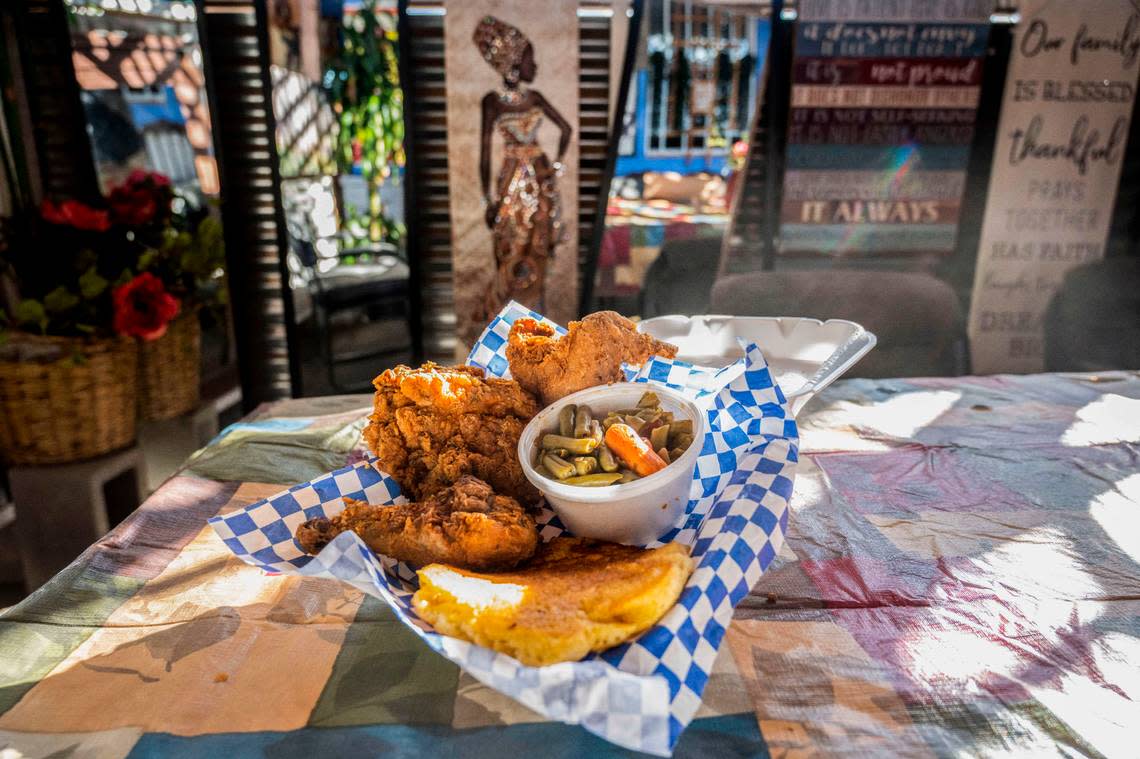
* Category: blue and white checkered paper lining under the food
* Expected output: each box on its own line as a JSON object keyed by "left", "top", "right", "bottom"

{"left": 210, "top": 302, "right": 799, "bottom": 756}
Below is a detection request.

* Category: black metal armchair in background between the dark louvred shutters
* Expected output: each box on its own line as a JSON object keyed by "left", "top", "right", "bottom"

{"left": 290, "top": 235, "right": 418, "bottom": 392}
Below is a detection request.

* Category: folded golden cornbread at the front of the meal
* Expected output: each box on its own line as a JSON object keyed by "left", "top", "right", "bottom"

{"left": 413, "top": 538, "right": 693, "bottom": 667}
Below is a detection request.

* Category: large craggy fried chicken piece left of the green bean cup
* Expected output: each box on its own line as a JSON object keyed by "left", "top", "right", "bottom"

{"left": 364, "top": 364, "right": 539, "bottom": 506}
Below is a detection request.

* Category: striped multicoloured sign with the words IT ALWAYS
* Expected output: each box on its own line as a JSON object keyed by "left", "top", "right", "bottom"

{"left": 780, "top": 0, "right": 993, "bottom": 255}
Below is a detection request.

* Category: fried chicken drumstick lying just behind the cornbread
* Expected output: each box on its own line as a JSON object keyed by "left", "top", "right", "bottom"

{"left": 296, "top": 475, "right": 538, "bottom": 570}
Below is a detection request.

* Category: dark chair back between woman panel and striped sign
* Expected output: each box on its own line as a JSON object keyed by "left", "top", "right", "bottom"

{"left": 637, "top": 236, "right": 723, "bottom": 319}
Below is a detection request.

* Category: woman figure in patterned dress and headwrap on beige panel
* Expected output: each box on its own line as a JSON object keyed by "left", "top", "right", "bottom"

{"left": 474, "top": 16, "right": 573, "bottom": 325}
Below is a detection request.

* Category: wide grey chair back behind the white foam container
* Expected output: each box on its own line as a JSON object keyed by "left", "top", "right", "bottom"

{"left": 710, "top": 269, "right": 966, "bottom": 377}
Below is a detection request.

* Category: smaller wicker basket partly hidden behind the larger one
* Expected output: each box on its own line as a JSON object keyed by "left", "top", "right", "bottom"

{"left": 139, "top": 310, "right": 202, "bottom": 422}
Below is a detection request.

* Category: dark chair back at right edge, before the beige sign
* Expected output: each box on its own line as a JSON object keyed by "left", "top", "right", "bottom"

{"left": 1045, "top": 258, "right": 1140, "bottom": 372}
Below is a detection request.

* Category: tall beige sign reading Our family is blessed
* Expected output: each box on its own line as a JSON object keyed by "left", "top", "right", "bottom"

{"left": 969, "top": 0, "right": 1140, "bottom": 374}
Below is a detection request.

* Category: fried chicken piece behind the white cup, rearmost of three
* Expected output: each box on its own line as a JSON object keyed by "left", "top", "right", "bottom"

{"left": 506, "top": 311, "right": 677, "bottom": 406}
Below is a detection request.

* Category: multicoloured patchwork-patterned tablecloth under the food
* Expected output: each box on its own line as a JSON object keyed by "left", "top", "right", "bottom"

{"left": 0, "top": 373, "right": 1140, "bottom": 759}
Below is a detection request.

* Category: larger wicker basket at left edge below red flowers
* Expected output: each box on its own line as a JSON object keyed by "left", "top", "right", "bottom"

{"left": 0, "top": 334, "right": 138, "bottom": 464}
